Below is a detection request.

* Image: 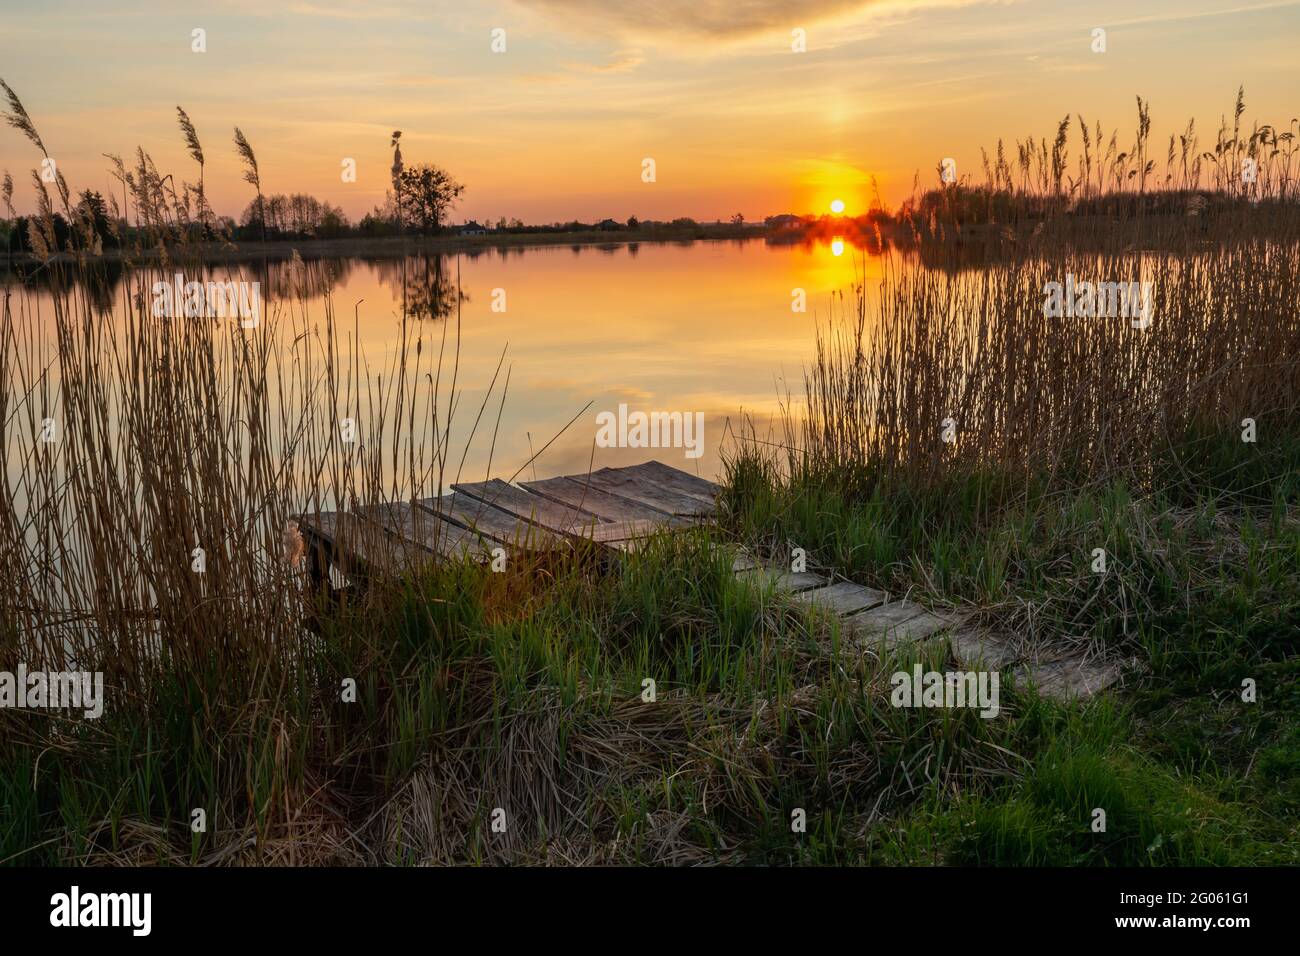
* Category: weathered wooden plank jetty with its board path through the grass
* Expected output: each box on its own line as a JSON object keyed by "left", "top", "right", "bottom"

{"left": 298, "top": 462, "right": 1121, "bottom": 700}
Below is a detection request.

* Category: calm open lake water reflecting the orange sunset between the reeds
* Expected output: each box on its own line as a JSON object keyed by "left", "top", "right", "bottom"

{"left": 12, "top": 241, "right": 879, "bottom": 489}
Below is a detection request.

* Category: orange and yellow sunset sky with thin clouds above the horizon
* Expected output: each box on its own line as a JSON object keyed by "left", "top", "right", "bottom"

{"left": 0, "top": 0, "right": 1300, "bottom": 222}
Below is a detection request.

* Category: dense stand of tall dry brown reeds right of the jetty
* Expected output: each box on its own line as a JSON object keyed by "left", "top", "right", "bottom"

{"left": 787, "top": 230, "right": 1300, "bottom": 494}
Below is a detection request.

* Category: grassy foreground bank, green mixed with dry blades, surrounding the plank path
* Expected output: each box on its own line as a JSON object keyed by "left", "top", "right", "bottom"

{"left": 0, "top": 444, "right": 1300, "bottom": 865}
